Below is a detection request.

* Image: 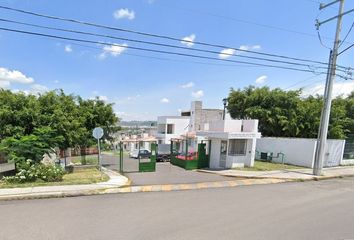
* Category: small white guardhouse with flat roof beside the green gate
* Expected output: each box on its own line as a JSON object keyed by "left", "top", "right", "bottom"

{"left": 197, "top": 120, "right": 261, "bottom": 168}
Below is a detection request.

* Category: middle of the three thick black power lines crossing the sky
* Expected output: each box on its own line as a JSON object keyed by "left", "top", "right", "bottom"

{"left": 0, "top": 18, "right": 341, "bottom": 71}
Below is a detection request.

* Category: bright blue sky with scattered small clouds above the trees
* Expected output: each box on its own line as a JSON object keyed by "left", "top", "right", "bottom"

{"left": 0, "top": 0, "right": 354, "bottom": 121}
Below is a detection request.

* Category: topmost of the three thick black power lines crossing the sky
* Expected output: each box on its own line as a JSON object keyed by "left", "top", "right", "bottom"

{"left": 0, "top": 5, "right": 345, "bottom": 68}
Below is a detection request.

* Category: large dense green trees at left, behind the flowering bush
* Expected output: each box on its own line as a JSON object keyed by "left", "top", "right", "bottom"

{"left": 0, "top": 89, "right": 119, "bottom": 166}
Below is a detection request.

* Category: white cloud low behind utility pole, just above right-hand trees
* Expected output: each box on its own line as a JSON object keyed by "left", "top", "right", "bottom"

{"left": 302, "top": 81, "right": 354, "bottom": 98}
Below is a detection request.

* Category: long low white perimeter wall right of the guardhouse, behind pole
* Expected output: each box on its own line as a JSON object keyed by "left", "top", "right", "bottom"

{"left": 256, "top": 138, "right": 345, "bottom": 168}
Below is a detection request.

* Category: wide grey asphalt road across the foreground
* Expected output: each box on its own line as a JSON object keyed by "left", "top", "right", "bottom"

{"left": 0, "top": 178, "right": 354, "bottom": 240}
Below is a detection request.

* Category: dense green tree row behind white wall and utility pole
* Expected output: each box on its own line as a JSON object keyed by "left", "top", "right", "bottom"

{"left": 228, "top": 86, "right": 354, "bottom": 139}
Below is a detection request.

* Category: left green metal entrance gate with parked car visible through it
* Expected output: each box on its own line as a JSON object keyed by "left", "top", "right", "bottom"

{"left": 118, "top": 141, "right": 157, "bottom": 173}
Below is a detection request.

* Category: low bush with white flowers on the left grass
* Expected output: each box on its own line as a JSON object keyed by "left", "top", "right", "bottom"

{"left": 3, "top": 159, "right": 65, "bottom": 183}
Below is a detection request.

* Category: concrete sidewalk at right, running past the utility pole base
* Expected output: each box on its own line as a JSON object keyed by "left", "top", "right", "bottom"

{"left": 199, "top": 166, "right": 354, "bottom": 181}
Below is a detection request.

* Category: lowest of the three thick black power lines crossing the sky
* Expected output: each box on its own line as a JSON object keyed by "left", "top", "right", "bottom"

{"left": 0, "top": 27, "right": 324, "bottom": 74}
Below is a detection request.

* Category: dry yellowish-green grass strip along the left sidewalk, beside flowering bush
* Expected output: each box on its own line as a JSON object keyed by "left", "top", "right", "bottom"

{"left": 0, "top": 167, "right": 109, "bottom": 188}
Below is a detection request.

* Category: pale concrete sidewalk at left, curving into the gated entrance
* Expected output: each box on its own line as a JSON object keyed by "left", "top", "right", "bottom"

{"left": 0, "top": 168, "right": 129, "bottom": 200}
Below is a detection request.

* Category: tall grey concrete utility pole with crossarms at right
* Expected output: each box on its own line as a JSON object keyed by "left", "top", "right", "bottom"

{"left": 313, "top": 0, "right": 345, "bottom": 176}
